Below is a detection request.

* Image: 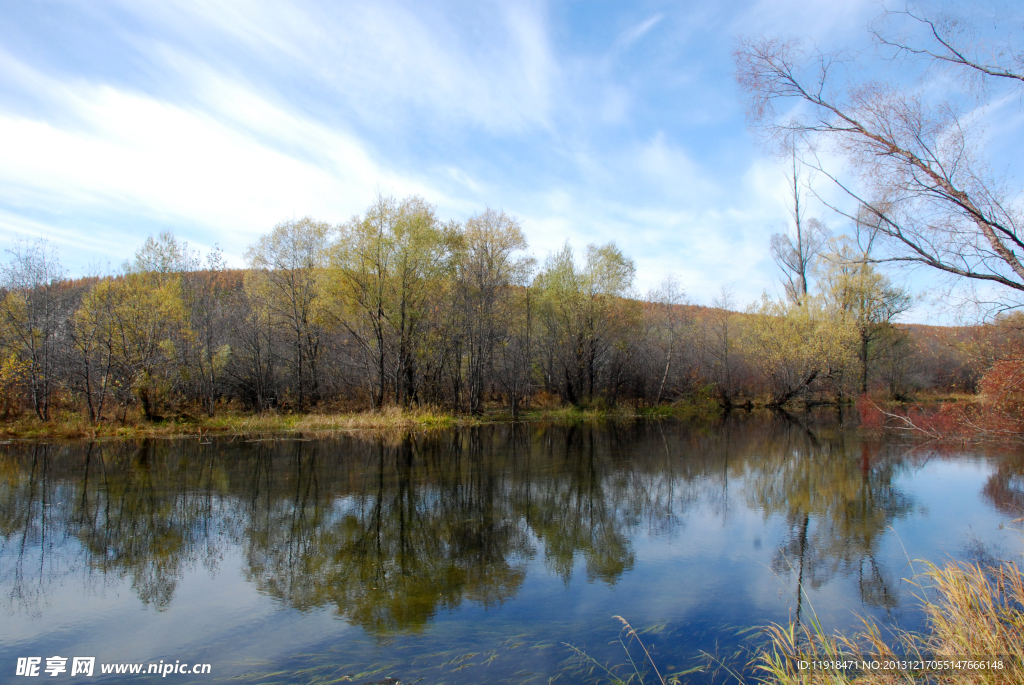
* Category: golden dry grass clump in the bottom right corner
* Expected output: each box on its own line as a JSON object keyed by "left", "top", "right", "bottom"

{"left": 753, "top": 562, "right": 1024, "bottom": 685}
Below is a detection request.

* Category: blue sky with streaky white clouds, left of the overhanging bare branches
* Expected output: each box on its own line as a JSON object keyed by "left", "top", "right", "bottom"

{"left": 0, "top": 0, "right": 1011, "bottom": 315}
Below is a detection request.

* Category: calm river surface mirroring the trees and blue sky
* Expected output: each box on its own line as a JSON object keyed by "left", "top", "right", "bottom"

{"left": 0, "top": 416, "right": 1024, "bottom": 683}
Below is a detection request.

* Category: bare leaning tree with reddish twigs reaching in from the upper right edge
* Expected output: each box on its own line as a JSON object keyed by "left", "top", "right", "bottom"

{"left": 734, "top": 12, "right": 1024, "bottom": 308}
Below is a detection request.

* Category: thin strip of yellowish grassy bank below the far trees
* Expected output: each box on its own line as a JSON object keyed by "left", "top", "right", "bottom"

{"left": 0, "top": 402, "right": 719, "bottom": 439}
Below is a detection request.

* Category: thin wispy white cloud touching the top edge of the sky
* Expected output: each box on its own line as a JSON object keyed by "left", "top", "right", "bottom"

{"left": 109, "top": 0, "right": 558, "bottom": 132}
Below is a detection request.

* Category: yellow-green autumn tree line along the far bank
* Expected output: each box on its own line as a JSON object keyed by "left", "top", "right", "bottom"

{"left": 0, "top": 197, "right": 979, "bottom": 422}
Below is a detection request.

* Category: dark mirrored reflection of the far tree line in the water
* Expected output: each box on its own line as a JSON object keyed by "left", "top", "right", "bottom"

{"left": 0, "top": 417, "right": 1007, "bottom": 636}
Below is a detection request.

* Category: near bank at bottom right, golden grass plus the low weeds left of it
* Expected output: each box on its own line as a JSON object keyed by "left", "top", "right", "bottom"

{"left": 563, "top": 562, "right": 1024, "bottom": 685}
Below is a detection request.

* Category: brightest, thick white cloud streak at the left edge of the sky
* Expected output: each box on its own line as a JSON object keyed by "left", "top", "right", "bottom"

{"left": 0, "top": 51, "right": 443, "bottom": 262}
